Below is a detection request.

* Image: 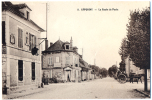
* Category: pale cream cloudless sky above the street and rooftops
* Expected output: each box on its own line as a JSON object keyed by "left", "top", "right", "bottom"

{"left": 12, "top": 1, "right": 150, "bottom": 69}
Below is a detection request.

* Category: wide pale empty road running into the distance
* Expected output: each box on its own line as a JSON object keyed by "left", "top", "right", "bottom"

{"left": 18, "top": 77, "right": 150, "bottom": 99}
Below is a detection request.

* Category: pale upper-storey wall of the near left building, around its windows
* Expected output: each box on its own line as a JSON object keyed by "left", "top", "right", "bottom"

{"left": 7, "top": 17, "right": 40, "bottom": 61}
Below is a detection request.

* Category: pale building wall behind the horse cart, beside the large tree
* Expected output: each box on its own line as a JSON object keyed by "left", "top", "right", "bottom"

{"left": 125, "top": 56, "right": 144, "bottom": 76}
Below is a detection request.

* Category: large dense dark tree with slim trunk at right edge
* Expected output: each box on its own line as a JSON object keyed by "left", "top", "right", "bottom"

{"left": 127, "top": 7, "right": 150, "bottom": 91}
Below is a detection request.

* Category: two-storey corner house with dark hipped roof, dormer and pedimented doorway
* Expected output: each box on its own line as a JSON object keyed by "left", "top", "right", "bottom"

{"left": 42, "top": 38, "right": 81, "bottom": 82}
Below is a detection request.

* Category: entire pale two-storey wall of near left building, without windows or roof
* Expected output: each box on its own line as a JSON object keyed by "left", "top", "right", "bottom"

{"left": 2, "top": 12, "right": 41, "bottom": 93}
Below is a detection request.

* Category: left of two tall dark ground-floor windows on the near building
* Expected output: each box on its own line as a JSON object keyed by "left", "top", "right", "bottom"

{"left": 18, "top": 60, "right": 23, "bottom": 81}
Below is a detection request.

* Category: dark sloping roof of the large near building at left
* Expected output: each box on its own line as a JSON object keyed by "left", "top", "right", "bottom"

{"left": 2, "top": 1, "right": 45, "bottom": 32}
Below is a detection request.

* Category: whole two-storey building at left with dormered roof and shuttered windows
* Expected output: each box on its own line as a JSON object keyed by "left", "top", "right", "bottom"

{"left": 2, "top": 2, "right": 44, "bottom": 93}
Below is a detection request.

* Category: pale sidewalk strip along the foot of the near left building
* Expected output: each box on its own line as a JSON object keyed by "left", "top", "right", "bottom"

{"left": 2, "top": 84, "right": 51, "bottom": 99}
